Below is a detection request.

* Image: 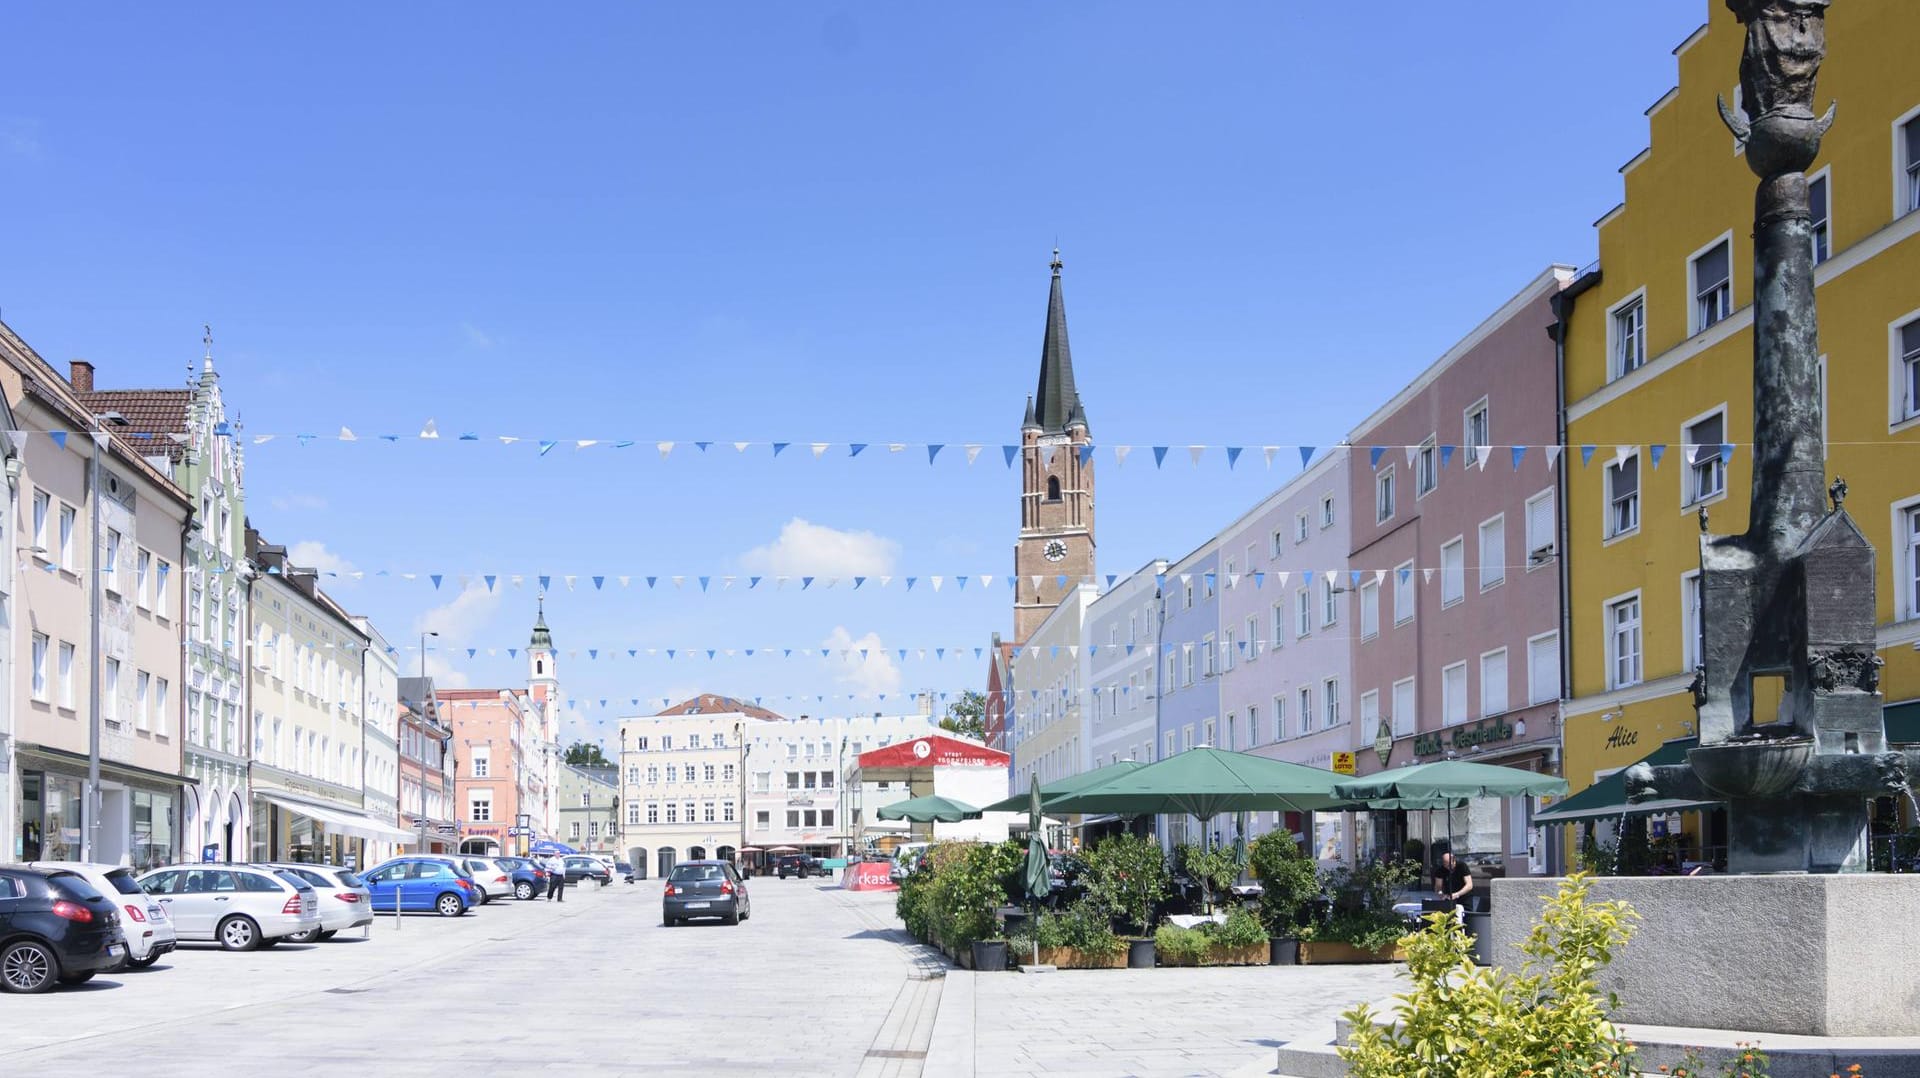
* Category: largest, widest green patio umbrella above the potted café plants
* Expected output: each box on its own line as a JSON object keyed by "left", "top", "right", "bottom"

{"left": 1046, "top": 747, "right": 1350, "bottom": 821}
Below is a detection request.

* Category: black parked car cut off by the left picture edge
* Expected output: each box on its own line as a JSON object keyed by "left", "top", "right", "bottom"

{"left": 0, "top": 867, "right": 127, "bottom": 992}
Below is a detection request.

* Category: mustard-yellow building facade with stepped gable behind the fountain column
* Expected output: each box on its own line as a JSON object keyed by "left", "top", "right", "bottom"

{"left": 1563, "top": 0, "right": 1920, "bottom": 826}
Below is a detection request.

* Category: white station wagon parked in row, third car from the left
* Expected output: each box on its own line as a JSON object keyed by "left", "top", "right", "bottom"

{"left": 140, "top": 865, "right": 321, "bottom": 951}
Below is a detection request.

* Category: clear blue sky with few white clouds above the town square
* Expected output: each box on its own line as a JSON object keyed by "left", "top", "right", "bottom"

{"left": 0, "top": 0, "right": 1724, "bottom": 749}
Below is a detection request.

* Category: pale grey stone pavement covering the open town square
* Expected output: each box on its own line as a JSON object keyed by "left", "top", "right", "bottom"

{"left": 0, "top": 878, "right": 1392, "bottom": 1078}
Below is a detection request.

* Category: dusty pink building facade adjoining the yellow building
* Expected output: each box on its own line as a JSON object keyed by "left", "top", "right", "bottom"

{"left": 1346, "top": 265, "right": 1574, "bottom": 874}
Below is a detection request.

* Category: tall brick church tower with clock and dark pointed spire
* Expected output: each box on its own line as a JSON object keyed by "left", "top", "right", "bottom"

{"left": 1014, "top": 250, "right": 1094, "bottom": 644}
